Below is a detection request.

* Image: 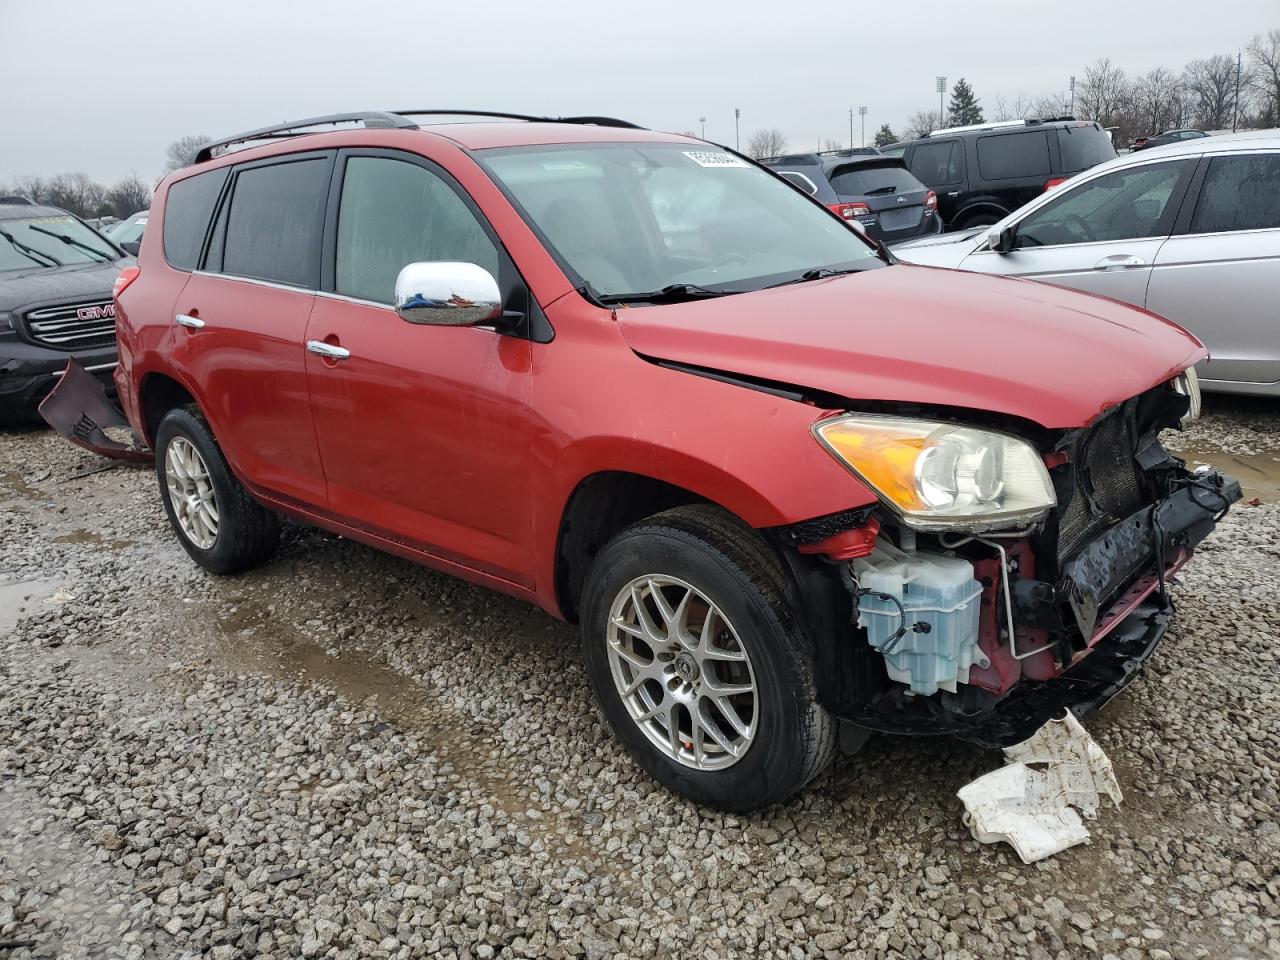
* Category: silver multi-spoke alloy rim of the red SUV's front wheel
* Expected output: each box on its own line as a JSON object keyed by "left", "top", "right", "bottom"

{"left": 607, "top": 573, "right": 759, "bottom": 771}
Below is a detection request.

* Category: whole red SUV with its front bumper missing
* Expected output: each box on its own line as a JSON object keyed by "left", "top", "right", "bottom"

{"left": 46, "top": 114, "right": 1239, "bottom": 809}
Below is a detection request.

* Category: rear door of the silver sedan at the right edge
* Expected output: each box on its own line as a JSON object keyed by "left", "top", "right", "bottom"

{"left": 1147, "top": 151, "right": 1280, "bottom": 384}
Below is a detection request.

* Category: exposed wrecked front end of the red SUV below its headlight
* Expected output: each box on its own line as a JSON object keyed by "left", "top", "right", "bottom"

{"left": 778, "top": 384, "right": 1240, "bottom": 746}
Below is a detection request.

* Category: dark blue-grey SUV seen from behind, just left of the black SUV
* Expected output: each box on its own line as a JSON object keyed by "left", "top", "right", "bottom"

{"left": 760, "top": 147, "right": 942, "bottom": 243}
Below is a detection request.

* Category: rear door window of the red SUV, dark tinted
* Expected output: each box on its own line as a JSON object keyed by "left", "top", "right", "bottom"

{"left": 219, "top": 157, "right": 329, "bottom": 288}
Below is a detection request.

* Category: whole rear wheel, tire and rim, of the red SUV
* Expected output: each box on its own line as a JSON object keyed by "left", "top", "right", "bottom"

{"left": 155, "top": 407, "right": 280, "bottom": 575}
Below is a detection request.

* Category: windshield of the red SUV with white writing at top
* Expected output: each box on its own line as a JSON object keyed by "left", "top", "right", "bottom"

{"left": 481, "top": 143, "right": 883, "bottom": 303}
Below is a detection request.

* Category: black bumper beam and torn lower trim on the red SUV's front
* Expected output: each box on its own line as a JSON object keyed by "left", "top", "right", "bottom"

{"left": 801, "top": 466, "right": 1240, "bottom": 748}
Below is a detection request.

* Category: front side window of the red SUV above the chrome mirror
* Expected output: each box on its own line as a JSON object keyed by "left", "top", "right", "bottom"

{"left": 335, "top": 156, "right": 498, "bottom": 303}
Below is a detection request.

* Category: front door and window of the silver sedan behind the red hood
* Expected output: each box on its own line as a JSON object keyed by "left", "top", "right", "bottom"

{"left": 961, "top": 157, "right": 1196, "bottom": 307}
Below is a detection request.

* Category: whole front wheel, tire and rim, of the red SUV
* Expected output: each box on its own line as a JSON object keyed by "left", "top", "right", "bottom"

{"left": 581, "top": 506, "right": 836, "bottom": 812}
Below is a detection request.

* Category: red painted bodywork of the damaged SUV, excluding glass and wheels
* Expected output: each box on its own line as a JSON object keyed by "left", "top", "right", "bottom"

{"left": 116, "top": 123, "right": 1204, "bottom": 613}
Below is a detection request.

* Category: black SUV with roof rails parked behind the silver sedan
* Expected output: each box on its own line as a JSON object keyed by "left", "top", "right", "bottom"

{"left": 882, "top": 118, "right": 1116, "bottom": 230}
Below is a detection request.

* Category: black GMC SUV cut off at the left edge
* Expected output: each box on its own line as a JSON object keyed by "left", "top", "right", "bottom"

{"left": 0, "top": 197, "right": 132, "bottom": 422}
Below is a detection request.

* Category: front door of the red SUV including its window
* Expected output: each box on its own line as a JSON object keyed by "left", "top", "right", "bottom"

{"left": 307, "top": 151, "right": 532, "bottom": 586}
